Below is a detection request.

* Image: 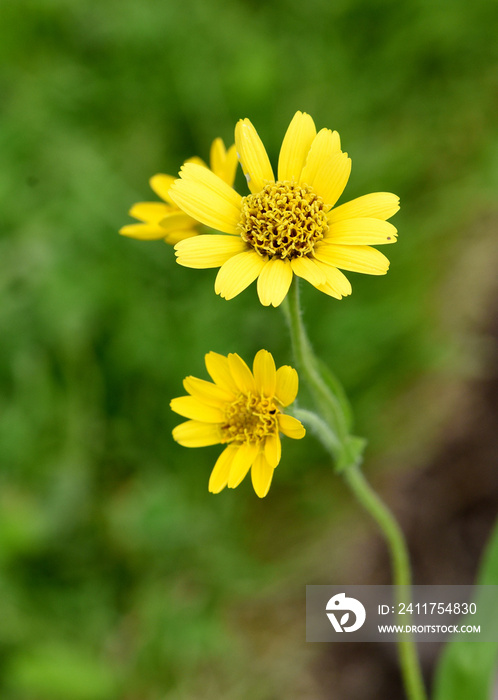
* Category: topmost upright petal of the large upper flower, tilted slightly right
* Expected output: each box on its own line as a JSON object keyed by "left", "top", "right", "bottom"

{"left": 278, "top": 112, "right": 316, "bottom": 182}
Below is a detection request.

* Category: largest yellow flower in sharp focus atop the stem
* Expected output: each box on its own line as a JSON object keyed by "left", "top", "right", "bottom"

{"left": 170, "top": 112, "right": 399, "bottom": 306}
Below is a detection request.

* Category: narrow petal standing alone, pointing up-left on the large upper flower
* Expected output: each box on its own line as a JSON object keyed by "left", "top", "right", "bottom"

{"left": 235, "top": 119, "right": 275, "bottom": 193}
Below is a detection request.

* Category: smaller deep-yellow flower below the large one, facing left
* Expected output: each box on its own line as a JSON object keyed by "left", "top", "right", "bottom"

{"left": 171, "top": 350, "right": 306, "bottom": 498}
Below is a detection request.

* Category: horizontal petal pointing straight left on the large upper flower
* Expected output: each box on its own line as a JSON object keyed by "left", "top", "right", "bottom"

{"left": 175, "top": 233, "right": 247, "bottom": 269}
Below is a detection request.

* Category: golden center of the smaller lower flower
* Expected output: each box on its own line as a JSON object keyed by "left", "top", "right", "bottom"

{"left": 221, "top": 394, "right": 279, "bottom": 443}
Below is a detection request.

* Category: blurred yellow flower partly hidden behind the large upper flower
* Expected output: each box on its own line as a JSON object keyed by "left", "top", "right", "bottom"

{"left": 119, "top": 138, "right": 237, "bottom": 245}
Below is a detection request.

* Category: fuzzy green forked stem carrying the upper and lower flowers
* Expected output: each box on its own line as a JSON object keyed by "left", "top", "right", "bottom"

{"left": 284, "top": 282, "right": 427, "bottom": 700}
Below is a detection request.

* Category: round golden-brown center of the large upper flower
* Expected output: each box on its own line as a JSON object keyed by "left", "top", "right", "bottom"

{"left": 238, "top": 182, "right": 328, "bottom": 260}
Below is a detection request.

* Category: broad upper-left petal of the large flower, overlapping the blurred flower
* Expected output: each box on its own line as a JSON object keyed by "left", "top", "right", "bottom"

{"left": 169, "top": 163, "right": 242, "bottom": 233}
